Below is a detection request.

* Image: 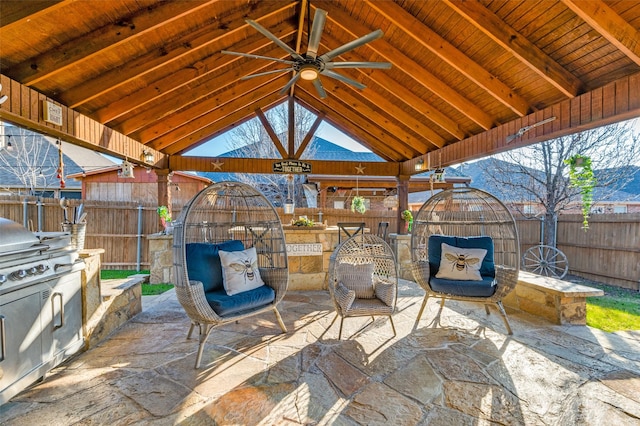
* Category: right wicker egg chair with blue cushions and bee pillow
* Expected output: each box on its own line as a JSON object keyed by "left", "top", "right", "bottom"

{"left": 411, "top": 188, "right": 520, "bottom": 334}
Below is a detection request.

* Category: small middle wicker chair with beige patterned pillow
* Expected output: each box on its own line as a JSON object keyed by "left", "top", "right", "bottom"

{"left": 328, "top": 233, "right": 398, "bottom": 339}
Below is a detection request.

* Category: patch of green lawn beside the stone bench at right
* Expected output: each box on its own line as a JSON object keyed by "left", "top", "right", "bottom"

{"left": 585, "top": 282, "right": 640, "bottom": 332}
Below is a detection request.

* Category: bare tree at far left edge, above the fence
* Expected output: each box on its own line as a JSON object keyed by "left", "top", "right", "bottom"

{"left": 0, "top": 122, "right": 58, "bottom": 195}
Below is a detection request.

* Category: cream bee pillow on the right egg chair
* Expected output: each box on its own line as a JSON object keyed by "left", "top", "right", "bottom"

{"left": 436, "top": 243, "right": 487, "bottom": 281}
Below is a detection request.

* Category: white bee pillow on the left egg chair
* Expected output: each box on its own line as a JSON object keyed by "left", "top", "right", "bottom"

{"left": 220, "top": 247, "right": 264, "bottom": 296}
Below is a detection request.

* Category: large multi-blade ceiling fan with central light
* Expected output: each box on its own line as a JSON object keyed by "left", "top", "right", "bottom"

{"left": 222, "top": 9, "right": 391, "bottom": 98}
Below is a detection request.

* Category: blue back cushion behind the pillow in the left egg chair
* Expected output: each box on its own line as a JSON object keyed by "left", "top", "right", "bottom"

{"left": 185, "top": 240, "right": 244, "bottom": 293}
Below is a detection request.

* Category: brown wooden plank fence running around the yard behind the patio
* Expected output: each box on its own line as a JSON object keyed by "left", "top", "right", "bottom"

{"left": 0, "top": 196, "right": 640, "bottom": 290}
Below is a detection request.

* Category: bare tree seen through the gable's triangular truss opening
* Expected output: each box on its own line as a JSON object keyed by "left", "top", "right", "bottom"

{"left": 224, "top": 103, "right": 316, "bottom": 210}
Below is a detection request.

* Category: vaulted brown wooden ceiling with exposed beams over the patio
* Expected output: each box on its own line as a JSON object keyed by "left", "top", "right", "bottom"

{"left": 0, "top": 0, "right": 640, "bottom": 175}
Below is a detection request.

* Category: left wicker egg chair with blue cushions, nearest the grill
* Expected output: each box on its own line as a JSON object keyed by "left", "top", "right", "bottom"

{"left": 173, "top": 182, "right": 289, "bottom": 368}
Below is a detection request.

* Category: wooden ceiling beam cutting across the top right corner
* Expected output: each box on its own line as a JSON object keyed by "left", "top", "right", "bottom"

{"left": 562, "top": 0, "right": 640, "bottom": 65}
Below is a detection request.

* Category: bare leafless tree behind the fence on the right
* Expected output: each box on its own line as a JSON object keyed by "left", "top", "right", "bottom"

{"left": 485, "top": 119, "right": 640, "bottom": 246}
